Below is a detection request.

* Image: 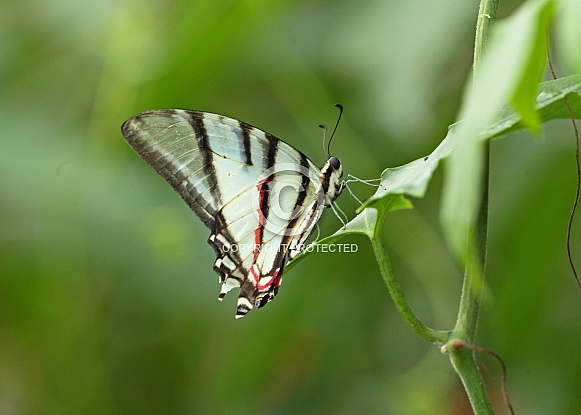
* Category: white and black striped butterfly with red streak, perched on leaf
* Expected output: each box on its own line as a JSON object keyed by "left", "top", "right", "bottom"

{"left": 121, "top": 106, "right": 345, "bottom": 318}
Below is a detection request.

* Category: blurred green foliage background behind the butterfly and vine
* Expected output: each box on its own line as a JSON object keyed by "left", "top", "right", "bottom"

{"left": 0, "top": 0, "right": 581, "bottom": 415}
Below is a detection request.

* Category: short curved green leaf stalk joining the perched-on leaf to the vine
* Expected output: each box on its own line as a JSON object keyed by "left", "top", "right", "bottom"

{"left": 369, "top": 226, "right": 449, "bottom": 343}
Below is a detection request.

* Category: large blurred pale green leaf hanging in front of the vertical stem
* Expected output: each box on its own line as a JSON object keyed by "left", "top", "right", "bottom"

{"left": 441, "top": 0, "right": 553, "bottom": 262}
